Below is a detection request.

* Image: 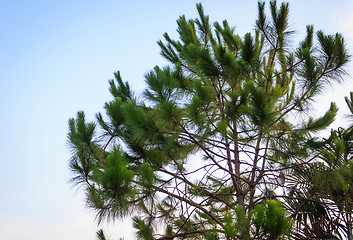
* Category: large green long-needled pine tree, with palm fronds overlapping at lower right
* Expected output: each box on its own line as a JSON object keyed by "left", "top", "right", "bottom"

{"left": 68, "top": 1, "right": 353, "bottom": 240}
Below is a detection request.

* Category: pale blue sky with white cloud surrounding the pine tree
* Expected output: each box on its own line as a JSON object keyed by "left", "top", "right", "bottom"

{"left": 0, "top": 0, "right": 353, "bottom": 240}
